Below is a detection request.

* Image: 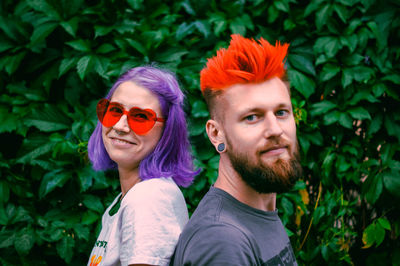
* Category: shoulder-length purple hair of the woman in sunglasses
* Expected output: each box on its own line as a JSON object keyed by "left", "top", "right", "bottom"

{"left": 88, "top": 66, "right": 199, "bottom": 187}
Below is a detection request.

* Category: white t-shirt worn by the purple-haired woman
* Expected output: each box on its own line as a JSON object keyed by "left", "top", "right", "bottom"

{"left": 88, "top": 178, "right": 189, "bottom": 266}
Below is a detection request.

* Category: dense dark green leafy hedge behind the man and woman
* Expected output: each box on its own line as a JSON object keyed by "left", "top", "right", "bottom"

{"left": 0, "top": 0, "right": 400, "bottom": 265}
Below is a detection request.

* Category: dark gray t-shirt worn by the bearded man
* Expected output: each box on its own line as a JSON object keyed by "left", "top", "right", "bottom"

{"left": 170, "top": 187, "right": 297, "bottom": 266}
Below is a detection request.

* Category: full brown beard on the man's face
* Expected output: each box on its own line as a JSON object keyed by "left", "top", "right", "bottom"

{"left": 226, "top": 137, "right": 303, "bottom": 194}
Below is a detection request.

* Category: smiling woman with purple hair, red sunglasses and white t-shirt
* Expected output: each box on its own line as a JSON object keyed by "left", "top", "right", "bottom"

{"left": 88, "top": 67, "right": 197, "bottom": 265}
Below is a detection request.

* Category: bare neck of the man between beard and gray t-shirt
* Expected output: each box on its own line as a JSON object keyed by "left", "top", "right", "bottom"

{"left": 214, "top": 156, "right": 276, "bottom": 211}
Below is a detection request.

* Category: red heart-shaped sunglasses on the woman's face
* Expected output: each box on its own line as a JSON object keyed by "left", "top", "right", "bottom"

{"left": 96, "top": 99, "right": 165, "bottom": 135}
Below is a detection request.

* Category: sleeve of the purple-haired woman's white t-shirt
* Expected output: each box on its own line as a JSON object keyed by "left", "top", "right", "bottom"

{"left": 120, "top": 179, "right": 188, "bottom": 265}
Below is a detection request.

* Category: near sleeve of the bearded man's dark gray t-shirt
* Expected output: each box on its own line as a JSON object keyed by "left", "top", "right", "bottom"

{"left": 179, "top": 224, "right": 255, "bottom": 266}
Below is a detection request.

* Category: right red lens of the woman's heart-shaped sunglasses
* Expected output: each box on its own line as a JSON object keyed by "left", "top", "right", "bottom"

{"left": 128, "top": 108, "right": 156, "bottom": 135}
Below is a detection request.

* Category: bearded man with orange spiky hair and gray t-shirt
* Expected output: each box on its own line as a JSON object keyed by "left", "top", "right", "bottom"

{"left": 171, "top": 35, "right": 302, "bottom": 266}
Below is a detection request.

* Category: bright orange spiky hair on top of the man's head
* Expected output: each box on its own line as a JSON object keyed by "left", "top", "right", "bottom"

{"left": 200, "top": 34, "right": 289, "bottom": 94}
